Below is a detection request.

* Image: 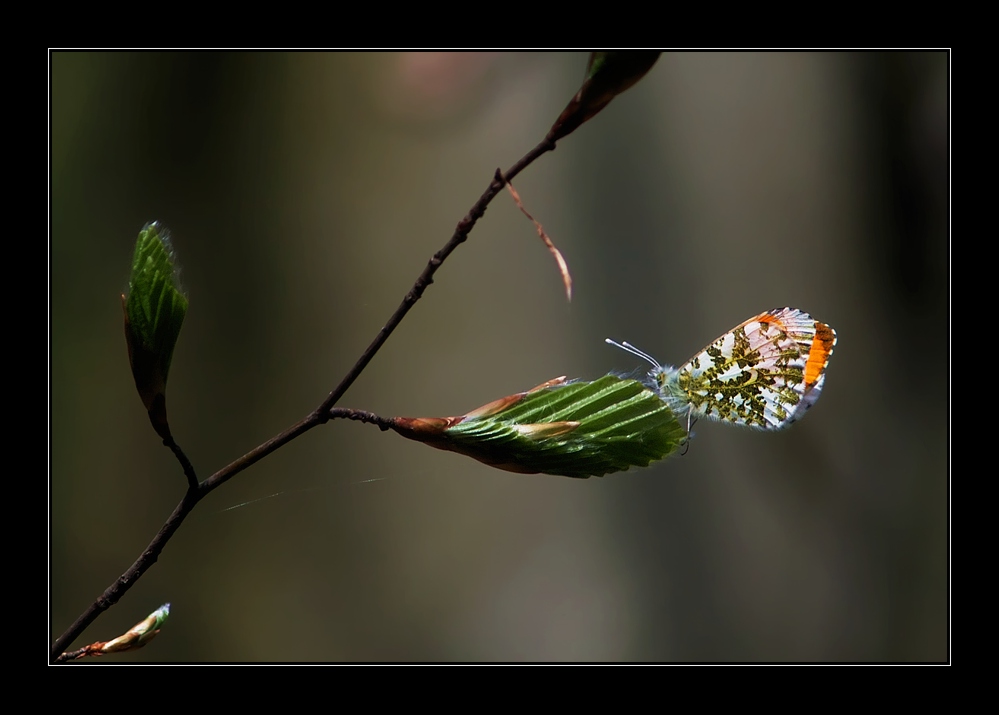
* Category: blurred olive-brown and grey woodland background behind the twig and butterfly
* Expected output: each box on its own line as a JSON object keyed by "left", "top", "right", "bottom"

{"left": 50, "top": 53, "right": 949, "bottom": 662}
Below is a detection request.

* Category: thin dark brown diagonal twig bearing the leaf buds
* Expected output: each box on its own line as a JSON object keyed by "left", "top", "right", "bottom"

{"left": 50, "top": 138, "right": 555, "bottom": 662}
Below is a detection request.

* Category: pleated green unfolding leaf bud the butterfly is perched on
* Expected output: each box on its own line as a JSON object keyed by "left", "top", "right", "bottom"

{"left": 392, "top": 375, "right": 686, "bottom": 478}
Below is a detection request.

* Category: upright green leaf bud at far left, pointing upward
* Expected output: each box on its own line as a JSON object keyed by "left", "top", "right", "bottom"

{"left": 122, "top": 221, "right": 188, "bottom": 439}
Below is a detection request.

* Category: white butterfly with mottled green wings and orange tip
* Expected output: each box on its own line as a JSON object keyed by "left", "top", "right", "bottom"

{"left": 606, "top": 308, "right": 836, "bottom": 433}
